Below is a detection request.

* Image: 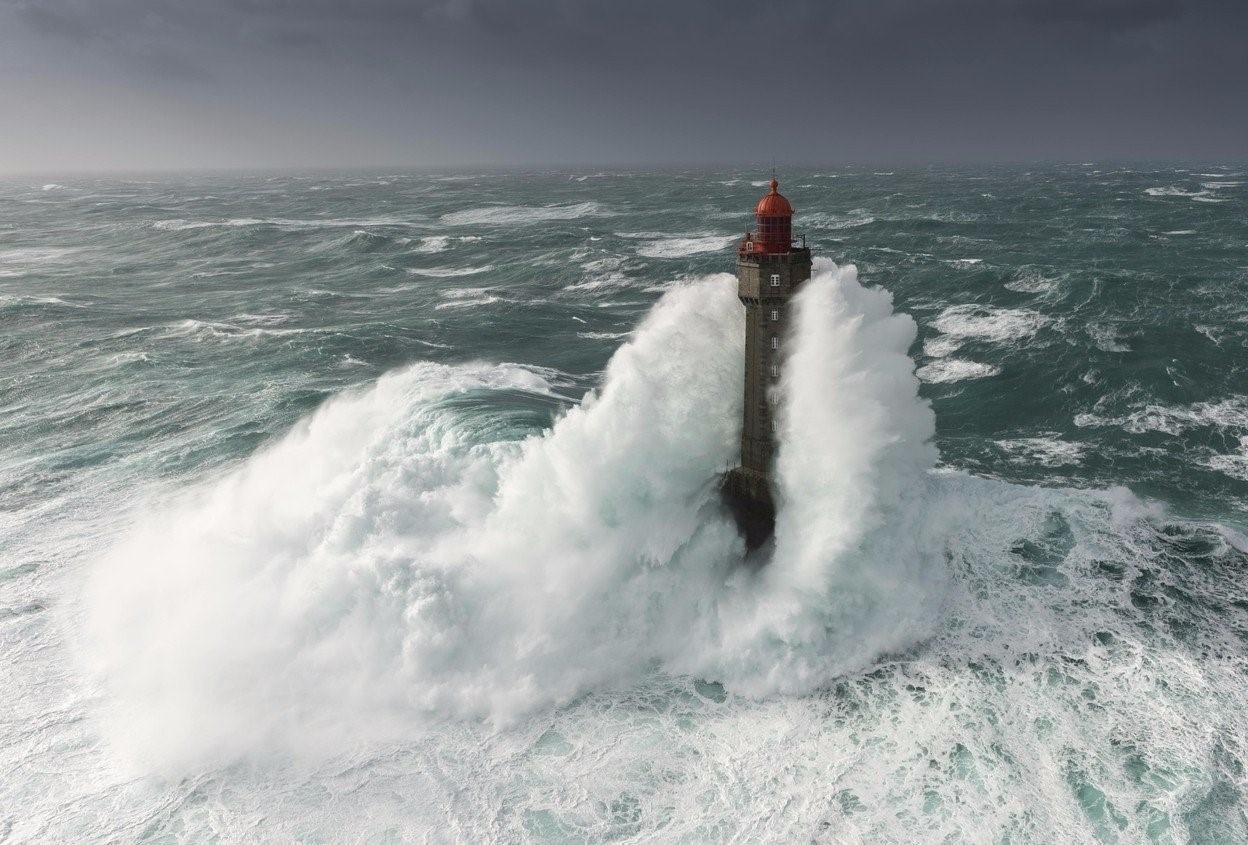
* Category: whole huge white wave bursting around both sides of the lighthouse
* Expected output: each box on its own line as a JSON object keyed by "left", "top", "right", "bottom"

{"left": 85, "top": 262, "right": 943, "bottom": 768}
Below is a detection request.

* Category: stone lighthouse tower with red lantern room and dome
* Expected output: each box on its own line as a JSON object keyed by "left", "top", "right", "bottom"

{"left": 724, "top": 178, "right": 810, "bottom": 549}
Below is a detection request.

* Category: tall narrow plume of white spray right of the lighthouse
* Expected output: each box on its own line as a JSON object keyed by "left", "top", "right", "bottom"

{"left": 678, "top": 260, "right": 957, "bottom": 695}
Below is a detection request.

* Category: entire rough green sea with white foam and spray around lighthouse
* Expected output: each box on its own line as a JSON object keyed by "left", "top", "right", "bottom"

{"left": 0, "top": 165, "right": 1248, "bottom": 843}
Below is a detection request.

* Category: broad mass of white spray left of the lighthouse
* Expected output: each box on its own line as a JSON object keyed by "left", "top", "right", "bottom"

{"left": 86, "top": 276, "right": 743, "bottom": 764}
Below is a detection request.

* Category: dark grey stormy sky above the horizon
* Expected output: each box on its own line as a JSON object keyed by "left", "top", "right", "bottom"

{"left": 0, "top": 0, "right": 1248, "bottom": 172}
